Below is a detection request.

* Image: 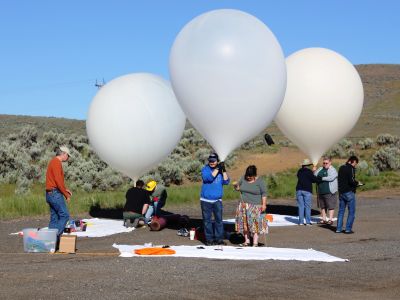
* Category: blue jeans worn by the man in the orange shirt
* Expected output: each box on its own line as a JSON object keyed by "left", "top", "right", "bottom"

{"left": 46, "top": 189, "right": 69, "bottom": 235}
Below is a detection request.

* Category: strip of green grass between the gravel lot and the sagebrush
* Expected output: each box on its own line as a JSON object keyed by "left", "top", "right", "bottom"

{"left": 0, "top": 169, "right": 400, "bottom": 219}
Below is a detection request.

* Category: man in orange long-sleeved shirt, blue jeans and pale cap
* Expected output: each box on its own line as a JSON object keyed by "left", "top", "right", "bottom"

{"left": 46, "top": 146, "right": 72, "bottom": 235}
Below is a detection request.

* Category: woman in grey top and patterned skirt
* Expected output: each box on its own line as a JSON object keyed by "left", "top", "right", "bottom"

{"left": 234, "top": 165, "right": 268, "bottom": 247}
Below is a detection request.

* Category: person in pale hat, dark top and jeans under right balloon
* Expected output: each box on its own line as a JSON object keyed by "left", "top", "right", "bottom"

{"left": 296, "top": 159, "right": 317, "bottom": 225}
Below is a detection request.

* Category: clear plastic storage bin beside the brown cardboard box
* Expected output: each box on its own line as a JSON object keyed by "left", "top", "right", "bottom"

{"left": 23, "top": 228, "right": 58, "bottom": 253}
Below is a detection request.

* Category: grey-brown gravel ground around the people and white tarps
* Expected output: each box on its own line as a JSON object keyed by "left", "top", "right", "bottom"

{"left": 0, "top": 190, "right": 400, "bottom": 299}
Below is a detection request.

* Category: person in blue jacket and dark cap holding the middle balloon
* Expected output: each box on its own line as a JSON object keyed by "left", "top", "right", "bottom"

{"left": 200, "top": 153, "right": 230, "bottom": 246}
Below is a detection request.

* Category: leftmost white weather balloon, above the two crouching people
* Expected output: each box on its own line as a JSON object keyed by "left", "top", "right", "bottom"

{"left": 86, "top": 73, "right": 186, "bottom": 179}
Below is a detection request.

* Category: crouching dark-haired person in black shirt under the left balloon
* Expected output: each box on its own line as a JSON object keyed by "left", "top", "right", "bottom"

{"left": 123, "top": 180, "right": 150, "bottom": 227}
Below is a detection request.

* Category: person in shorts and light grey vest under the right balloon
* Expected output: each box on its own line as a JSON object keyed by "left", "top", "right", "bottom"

{"left": 314, "top": 157, "right": 338, "bottom": 225}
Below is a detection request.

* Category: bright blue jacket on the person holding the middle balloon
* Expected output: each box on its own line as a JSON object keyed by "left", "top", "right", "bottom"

{"left": 200, "top": 165, "right": 230, "bottom": 200}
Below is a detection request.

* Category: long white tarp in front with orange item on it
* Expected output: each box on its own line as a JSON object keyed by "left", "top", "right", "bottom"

{"left": 113, "top": 244, "right": 348, "bottom": 262}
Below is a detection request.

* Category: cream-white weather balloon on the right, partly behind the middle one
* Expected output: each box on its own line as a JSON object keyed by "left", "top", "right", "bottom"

{"left": 275, "top": 48, "right": 364, "bottom": 164}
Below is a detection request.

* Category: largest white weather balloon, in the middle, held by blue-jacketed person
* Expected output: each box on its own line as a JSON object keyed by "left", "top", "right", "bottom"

{"left": 169, "top": 9, "right": 286, "bottom": 160}
